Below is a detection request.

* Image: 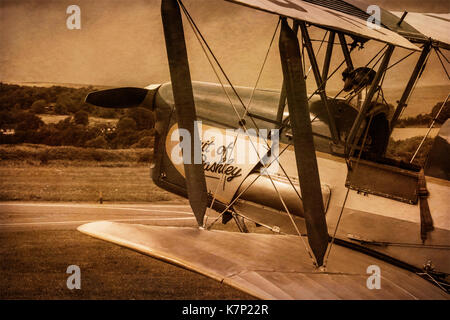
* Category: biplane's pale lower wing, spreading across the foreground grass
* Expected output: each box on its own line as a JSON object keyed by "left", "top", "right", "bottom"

{"left": 78, "top": 221, "right": 448, "bottom": 299}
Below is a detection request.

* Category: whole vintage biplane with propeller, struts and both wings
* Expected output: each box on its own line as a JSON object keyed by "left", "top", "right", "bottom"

{"left": 78, "top": 0, "right": 450, "bottom": 299}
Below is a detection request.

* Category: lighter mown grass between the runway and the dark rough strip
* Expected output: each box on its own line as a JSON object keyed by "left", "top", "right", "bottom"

{"left": 0, "top": 162, "right": 181, "bottom": 202}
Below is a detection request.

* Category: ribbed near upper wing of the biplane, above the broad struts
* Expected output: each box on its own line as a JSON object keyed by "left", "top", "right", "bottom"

{"left": 227, "top": 0, "right": 418, "bottom": 50}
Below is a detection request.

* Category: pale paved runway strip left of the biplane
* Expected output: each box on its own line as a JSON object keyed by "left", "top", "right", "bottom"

{"left": 0, "top": 202, "right": 196, "bottom": 231}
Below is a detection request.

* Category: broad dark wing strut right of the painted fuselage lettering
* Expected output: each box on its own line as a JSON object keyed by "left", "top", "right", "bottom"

{"left": 279, "top": 18, "right": 328, "bottom": 266}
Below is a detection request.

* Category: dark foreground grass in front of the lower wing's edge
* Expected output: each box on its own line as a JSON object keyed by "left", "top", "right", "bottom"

{"left": 0, "top": 230, "right": 252, "bottom": 300}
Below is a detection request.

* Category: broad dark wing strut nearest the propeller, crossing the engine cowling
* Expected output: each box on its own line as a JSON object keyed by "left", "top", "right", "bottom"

{"left": 161, "top": 0, "right": 208, "bottom": 226}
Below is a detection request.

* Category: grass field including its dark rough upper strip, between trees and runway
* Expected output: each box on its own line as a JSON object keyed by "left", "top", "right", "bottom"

{"left": 0, "top": 144, "right": 180, "bottom": 202}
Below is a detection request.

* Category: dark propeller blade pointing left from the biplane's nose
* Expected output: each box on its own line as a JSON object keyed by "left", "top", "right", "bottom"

{"left": 85, "top": 87, "right": 149, "bottom": 109}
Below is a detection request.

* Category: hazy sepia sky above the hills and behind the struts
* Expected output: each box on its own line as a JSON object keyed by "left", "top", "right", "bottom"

{"left": 0, "top": 0, "right": 450, "bottom": 95}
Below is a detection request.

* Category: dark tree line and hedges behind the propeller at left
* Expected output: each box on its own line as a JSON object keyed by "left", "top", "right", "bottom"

{"left": 0, "top": 83, "right": 155, "bottom": 149}
